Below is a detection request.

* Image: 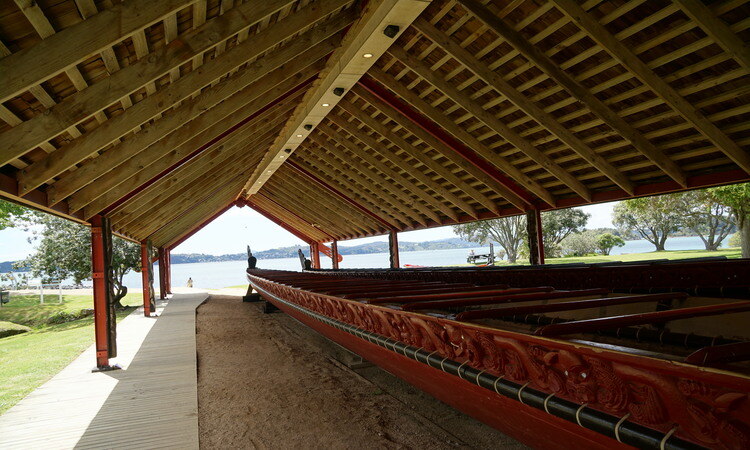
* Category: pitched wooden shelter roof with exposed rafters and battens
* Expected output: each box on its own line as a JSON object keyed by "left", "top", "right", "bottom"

{"left": 0, "top": 0, "right": 750, "bottom": 247}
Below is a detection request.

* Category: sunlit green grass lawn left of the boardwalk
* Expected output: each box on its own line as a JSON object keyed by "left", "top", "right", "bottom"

{"left": 0, "top": 293, "right": 143, "bottom": 414}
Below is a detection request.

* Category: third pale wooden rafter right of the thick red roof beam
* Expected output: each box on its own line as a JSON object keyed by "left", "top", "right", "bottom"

{"left": 460, "top": 0, "right": 696, "bottom": 188}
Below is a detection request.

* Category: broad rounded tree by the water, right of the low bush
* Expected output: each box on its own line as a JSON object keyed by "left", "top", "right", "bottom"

{"left": 612, "top": 194, "right": 685, "bottom": 252}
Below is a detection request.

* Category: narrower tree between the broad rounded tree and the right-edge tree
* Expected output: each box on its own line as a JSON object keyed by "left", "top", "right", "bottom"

{"left": 676, "top": 189, "right": 734, "bottom": 251}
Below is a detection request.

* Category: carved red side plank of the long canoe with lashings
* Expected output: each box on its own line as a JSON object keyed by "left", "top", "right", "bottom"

{"left": 248, "top": 270, "right": 750, "bottom": 448}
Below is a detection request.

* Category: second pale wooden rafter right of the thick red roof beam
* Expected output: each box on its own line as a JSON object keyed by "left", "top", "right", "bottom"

{"left": 414, "top": 19, "right": 633, "bottom": 194}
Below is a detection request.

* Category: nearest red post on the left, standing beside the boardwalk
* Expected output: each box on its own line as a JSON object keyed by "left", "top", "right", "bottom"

{"left": 91, "top": 215, "right": 109, "bottom": 369}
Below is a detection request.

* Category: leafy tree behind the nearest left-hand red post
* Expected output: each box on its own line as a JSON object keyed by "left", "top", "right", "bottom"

{"left": 23, "top": 213, "right": 141, "bottom": 308}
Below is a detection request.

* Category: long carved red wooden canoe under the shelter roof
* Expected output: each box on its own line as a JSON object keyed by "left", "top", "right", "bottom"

{"left": 248, "top": 260, "right": 750, "bottom": 449}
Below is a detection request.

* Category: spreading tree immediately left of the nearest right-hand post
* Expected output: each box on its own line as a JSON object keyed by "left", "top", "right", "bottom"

{"left": 453, "top": 215, "right": 526, "bottom": 264}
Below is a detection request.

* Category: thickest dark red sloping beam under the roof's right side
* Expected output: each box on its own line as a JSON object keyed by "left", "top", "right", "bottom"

{"left": 357, "top": 75, "right": 537, "bottom": 205}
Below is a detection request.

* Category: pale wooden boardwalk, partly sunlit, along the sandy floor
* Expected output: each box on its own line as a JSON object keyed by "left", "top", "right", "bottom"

{"left": 0, "top": 293, "right": 208, "bottom": 450}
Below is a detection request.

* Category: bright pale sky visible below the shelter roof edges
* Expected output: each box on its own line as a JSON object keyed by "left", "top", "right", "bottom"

{"left": 0, "top": 203, "right": 614, "bottom": 261}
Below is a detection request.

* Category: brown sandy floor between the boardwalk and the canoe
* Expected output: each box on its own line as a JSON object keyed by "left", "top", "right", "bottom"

{"left": 196, "top": 296, "right": 524, "bottom": 449}
